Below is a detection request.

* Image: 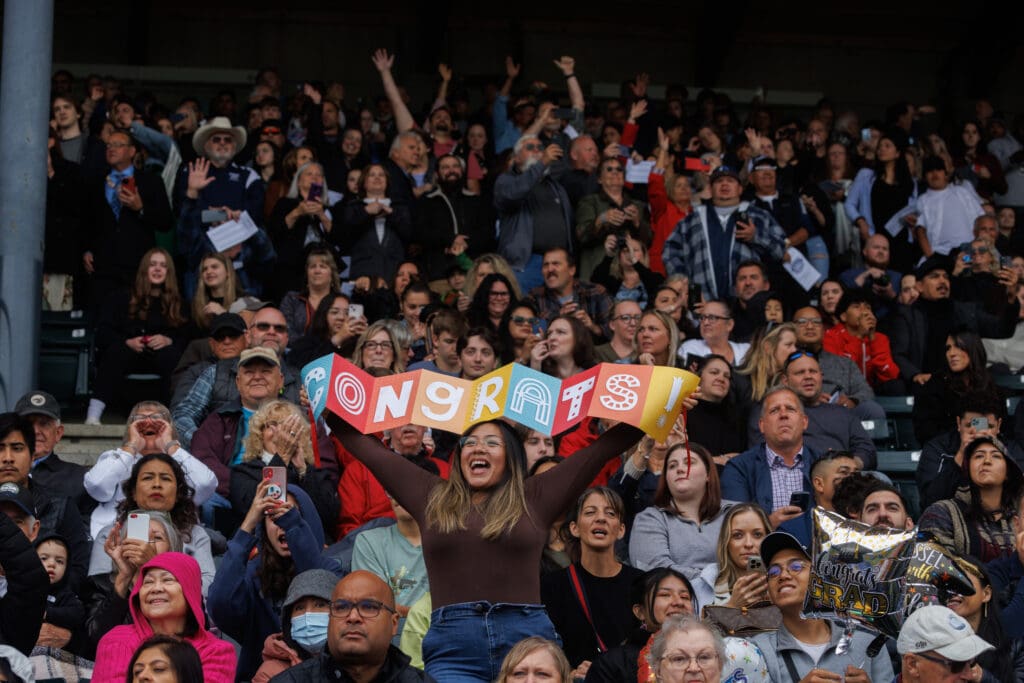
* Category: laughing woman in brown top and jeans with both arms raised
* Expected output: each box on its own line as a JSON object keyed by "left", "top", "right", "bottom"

{"left": 325, "top": 400, "right": 663, "bottom": 683}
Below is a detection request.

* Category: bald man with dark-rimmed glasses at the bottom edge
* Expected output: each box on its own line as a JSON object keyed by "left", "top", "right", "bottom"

{"left": 271, "top": 571, "right": 434, "bottom": 683}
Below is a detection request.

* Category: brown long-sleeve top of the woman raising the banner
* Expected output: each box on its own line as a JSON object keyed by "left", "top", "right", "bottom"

{"left": 327, "top": 415, "right": 643, "bottom": 608}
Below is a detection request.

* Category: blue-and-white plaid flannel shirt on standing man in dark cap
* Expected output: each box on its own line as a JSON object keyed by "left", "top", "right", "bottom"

{"left": 662, "top": 202, "right": 785, "bottom": 299}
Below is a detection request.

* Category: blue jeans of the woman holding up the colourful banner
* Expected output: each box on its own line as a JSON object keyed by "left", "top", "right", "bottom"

{"left": 423, "top": 602, "right": 562, "bottom": 683}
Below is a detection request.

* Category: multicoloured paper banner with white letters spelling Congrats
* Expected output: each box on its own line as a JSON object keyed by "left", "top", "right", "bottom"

{"left": 302, "top": 353, "right": 700, "bottom": 440}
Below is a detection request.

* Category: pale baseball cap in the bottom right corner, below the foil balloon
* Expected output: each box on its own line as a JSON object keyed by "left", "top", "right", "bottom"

{"left": 896, "top": 605, "right": 995, "bottom": 661}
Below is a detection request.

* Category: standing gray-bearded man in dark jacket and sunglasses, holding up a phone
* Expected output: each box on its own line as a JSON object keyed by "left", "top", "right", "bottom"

{"left": 495, "top": 135, "right": 572, "bottom": 292}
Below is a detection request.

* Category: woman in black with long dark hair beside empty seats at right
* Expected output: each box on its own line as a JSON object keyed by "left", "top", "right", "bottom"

{"left": 912, "top": 330, "right": 999, "bottom": 444}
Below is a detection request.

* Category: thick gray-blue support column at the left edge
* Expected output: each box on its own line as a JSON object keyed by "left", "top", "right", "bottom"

{"left": 0, "top": 0, "right": 53, "bottom": 411}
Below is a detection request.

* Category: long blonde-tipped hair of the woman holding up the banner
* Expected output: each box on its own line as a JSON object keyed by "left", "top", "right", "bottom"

{"left": 426, "top": 420, "right": 529, "bottom": 541}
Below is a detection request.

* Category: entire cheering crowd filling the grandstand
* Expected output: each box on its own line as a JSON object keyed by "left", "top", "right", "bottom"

{"left": 0, "top": 45, "right": 1024, "bottom": 683}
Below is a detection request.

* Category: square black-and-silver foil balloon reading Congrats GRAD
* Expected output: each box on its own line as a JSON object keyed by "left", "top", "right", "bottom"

{"left": 804, "top": 507, "right": 915, "bottom": 638}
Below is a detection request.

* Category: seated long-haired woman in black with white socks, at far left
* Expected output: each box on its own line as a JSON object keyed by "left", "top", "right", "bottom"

{"left": 85, "top": 247, "right": 185, "bottom": 425}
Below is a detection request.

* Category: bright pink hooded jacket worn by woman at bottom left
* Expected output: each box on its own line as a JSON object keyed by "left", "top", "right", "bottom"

{"left": 92, "top": 553, "right": 236, "bottom": 683}
